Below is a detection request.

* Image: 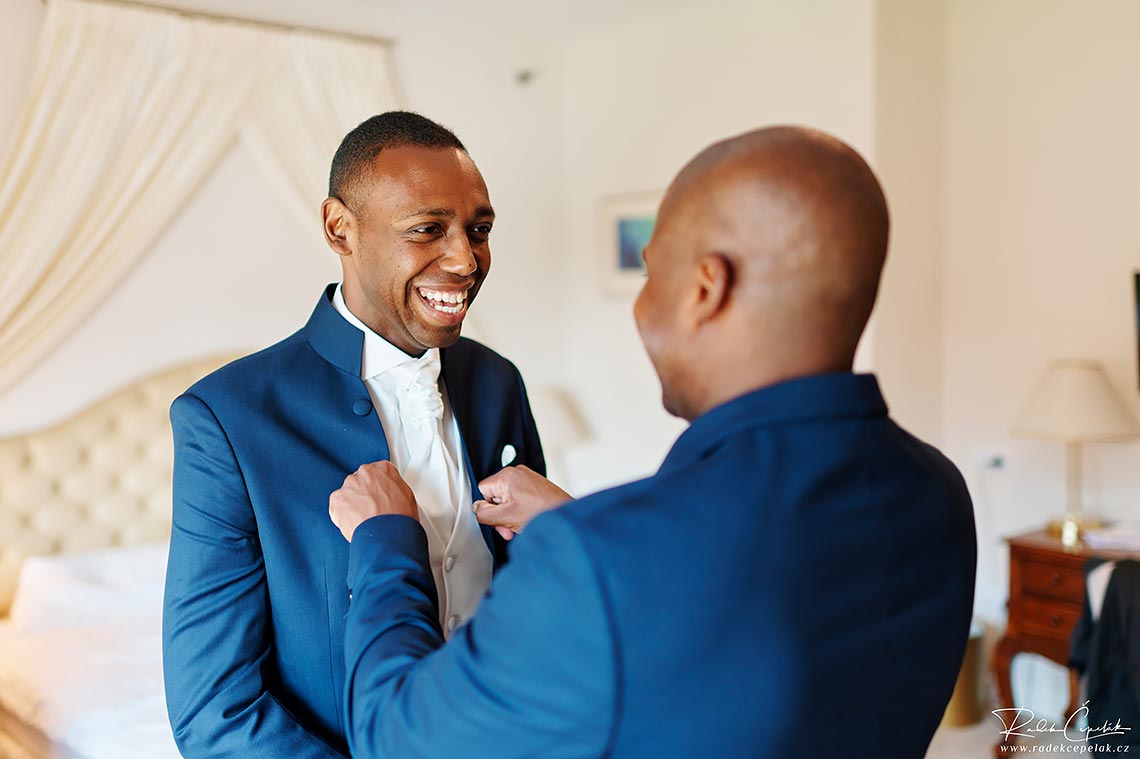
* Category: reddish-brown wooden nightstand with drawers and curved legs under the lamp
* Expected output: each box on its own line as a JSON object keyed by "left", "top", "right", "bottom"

{"left": 993, "top": 530, "right": 1137, "bottom": 757}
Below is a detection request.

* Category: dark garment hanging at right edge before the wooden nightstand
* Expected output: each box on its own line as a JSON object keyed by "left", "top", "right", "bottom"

{"left": 1069, "top": 560, "right": 1140, "bottom": 746}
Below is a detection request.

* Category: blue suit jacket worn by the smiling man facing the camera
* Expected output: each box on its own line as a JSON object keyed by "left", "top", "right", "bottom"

{"left": 163, "top": 287, "right": 544, "bottom": 759}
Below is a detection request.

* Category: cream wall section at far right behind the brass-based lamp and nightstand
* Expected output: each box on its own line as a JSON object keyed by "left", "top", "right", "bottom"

{"left": 943, "top": 0, "right": 1140, "bottom": 711}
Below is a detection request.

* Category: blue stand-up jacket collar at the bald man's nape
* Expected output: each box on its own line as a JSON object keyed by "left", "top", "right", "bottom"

{"left": 660, "top": 372, "right": 887, "bottom": 472}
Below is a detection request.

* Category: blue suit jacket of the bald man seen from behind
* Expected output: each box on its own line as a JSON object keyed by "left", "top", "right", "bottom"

{"left": 345, "top": 374, "right": 976, "bottom": 759}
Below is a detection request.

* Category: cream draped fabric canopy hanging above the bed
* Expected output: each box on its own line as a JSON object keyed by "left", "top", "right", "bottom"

{"left": 0, "top": 0, "right": 397, "bottom": 392}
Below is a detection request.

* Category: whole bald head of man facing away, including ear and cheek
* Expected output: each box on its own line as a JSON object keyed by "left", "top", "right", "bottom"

{"left": 635, "top": 127, "right": 888, "bottom": 418}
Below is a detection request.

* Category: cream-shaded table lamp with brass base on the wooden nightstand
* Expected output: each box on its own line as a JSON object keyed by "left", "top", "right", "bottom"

{"left": 1012, "top": 359, "right": 1140, "bottom": 546}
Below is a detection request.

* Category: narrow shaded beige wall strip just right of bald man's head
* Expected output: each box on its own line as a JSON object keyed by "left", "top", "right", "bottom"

{"left": 871, "top": 0, "right": 946, "bottom": 444}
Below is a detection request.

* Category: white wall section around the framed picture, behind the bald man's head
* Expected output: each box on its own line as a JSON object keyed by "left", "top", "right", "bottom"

{"left": 562, "top": 0, "right": 872, "bottom": 491}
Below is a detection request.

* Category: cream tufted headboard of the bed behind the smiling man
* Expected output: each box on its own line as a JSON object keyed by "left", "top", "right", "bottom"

{"left": 0, "top": 356, "right": 234, "bottom": 617}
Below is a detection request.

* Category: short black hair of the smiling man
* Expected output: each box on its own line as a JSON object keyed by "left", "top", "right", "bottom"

{"left": 328, "top": 111, "right": 467, "bottom": 210}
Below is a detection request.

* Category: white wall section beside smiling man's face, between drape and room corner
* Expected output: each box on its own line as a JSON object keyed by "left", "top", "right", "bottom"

{"left": 393, "top": 24, "right": 565, "bottom": 385}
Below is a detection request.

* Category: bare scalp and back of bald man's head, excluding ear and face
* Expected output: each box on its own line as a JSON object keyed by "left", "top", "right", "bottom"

{"left": 662, "top": 127, "right": 888, "bottom": 346}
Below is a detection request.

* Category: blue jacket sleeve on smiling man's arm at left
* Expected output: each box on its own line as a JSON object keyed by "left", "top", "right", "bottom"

{"left": 162, "top": 394, "right": 343, "bottom": 759}
